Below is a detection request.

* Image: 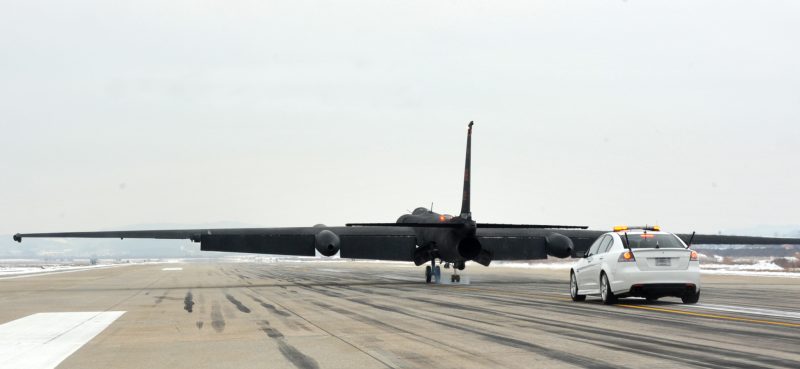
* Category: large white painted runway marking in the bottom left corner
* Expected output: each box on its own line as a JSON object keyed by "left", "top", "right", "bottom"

{"left": 0, "top": 311, "right": 125, "bottom": 369}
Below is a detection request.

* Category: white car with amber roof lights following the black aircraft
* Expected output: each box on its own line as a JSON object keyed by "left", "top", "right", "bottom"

{"left": 569, "top": 226, "right": 700, "bottom": 304}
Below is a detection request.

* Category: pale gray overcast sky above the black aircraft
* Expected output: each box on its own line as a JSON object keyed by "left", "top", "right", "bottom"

{"left": 0, "top": 0, "right": 800, "bottom": 233}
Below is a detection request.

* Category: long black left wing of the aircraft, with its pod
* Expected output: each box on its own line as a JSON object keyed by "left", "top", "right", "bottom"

{"left": 14, "top": 227, "right": 416, "bottom": 261}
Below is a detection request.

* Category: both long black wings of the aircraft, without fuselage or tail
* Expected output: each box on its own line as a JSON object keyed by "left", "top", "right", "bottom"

{"left": 14, "top": 227, "right": 800, "bottom": 265}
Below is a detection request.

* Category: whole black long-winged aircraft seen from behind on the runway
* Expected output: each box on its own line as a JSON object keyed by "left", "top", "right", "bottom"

{"left": 14, "top": 122, "right": 800, "bottom": 283}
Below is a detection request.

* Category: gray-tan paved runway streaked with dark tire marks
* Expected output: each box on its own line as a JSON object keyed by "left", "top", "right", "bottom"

{"left": 0, "top": 261, "right": 800, "bottom": 369}
